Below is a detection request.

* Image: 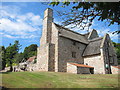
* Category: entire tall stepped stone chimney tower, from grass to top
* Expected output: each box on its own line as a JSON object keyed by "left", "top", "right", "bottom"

{"left": 37, "top": 8, "right": 55, "bottom": 71}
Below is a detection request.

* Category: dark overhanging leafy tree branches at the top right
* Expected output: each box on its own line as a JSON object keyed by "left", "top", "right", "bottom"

{"left": 49, "top": 2, "right": 120, "bottom": 34}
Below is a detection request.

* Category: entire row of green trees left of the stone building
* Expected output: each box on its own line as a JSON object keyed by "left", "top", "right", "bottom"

{"left": 0, "top": 40, "right": 38, "bottom": 71}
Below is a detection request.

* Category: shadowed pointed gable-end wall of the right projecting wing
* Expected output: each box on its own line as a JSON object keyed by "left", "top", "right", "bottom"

{"left": 101, "top": 34, "right": 118, "bottom": 74}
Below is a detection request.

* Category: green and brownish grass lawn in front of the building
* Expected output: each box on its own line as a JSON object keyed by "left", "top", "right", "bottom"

{"left": 0, "top": 72, "right": 118, "bottom": 88}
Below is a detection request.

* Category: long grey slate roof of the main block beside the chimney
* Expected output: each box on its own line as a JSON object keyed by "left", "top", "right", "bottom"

{"left": 54, "top": 23, "right": 89, "bottom": 44}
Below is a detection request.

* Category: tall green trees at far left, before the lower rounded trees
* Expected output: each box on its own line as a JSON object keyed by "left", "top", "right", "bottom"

{"left": 0, "top": 40, "right": 21, "bottom": 71}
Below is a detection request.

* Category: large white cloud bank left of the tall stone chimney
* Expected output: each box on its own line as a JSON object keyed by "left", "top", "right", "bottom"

{"left": 0, "top": 6, "right": 42, "bottom": 38}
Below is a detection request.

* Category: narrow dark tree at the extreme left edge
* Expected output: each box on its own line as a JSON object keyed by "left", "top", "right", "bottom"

{"left": 0, "top": 46, "right": 6, "bottom": 70}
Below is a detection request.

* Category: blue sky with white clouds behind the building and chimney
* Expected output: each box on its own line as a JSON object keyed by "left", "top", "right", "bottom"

{"left": 0, "top": 2, "right": 119, "bottom": 52}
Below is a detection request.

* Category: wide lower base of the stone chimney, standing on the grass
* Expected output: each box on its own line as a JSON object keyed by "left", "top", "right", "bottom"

{"left": 37, "top": 43, "right": 55, "bottom": 71}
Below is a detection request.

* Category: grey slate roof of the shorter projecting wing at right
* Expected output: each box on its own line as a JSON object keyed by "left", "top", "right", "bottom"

{"left": 83, "top": 37, "right": 103, "bottom": 56}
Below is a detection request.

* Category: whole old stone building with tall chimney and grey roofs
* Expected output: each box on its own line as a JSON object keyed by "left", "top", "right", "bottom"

{"left": 37, "top": 8, "right": 117, "bottom": 74}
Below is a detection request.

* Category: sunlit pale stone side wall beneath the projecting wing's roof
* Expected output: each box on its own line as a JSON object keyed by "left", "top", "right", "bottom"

{"left": 84, "top": 55, "right": 105, "bottom": 74}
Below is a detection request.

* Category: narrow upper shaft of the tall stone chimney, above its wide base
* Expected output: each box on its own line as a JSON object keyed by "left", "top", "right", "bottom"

{"left": 40, "top": 8, "right": 53, "bottom": 45}
